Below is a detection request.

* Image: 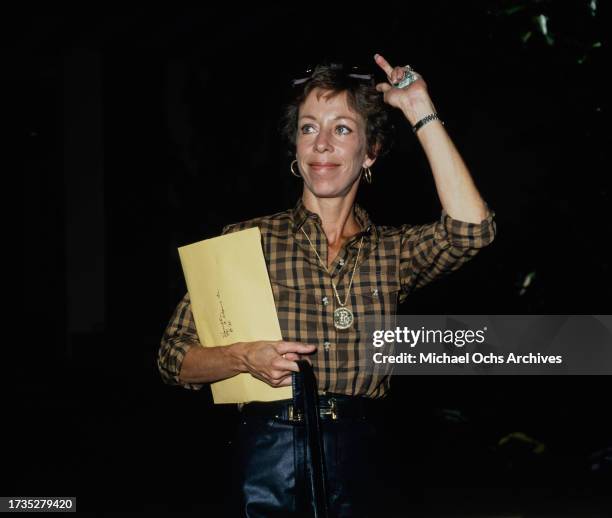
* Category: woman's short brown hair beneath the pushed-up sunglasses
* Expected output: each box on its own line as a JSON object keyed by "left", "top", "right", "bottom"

{"left": 279, "top": 63, "right": 395, "bottom": 158}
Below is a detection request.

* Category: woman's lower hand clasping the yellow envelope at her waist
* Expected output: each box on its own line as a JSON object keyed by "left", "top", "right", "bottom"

{"left": 242, "top": 340, "right": 317, "bottom": 387}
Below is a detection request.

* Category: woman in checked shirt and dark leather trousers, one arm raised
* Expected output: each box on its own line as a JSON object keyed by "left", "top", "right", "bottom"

{"left": 158, "top": 54, "right": 495, "bottom": 516}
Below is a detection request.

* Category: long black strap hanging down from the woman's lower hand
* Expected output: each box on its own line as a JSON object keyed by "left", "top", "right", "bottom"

{"left": 292, "top": 360, "right": 329, "bottom": 518}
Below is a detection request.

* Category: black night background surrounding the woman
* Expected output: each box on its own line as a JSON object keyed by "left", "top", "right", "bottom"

{"left": 9, "top": 1, "right": 612, "bottom": 516}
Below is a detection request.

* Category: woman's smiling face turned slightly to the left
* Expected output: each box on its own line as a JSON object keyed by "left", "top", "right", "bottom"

{"left": 296, "top": 89, "right": 374, "bottom": 198}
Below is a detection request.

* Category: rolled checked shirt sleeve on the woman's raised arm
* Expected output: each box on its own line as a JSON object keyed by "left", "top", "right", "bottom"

{"left": 400, "top": 206, "right": 496, "bottom": 302}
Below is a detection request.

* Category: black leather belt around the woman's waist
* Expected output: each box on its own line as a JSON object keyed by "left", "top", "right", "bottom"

{"left": 242, "top": 392, "right": 382, "bottom": 422}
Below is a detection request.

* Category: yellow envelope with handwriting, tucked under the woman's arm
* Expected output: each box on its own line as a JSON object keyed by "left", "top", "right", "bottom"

{"left": 178, "top": 227, "right": 292, "bottom": 403}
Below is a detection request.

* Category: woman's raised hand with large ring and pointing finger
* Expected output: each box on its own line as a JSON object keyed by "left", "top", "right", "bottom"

{"left": 374, "top": 54, "right": 435, "bottom": 124}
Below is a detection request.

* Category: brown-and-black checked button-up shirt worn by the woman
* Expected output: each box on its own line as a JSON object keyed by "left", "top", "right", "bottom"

{"left": 157, "top": 199, "right": 495, "bottom": 398}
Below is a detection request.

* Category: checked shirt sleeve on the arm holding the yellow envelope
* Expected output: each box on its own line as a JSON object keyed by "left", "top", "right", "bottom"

{"left": 157, "top": 293, "right": 205, "bottom": 390}
